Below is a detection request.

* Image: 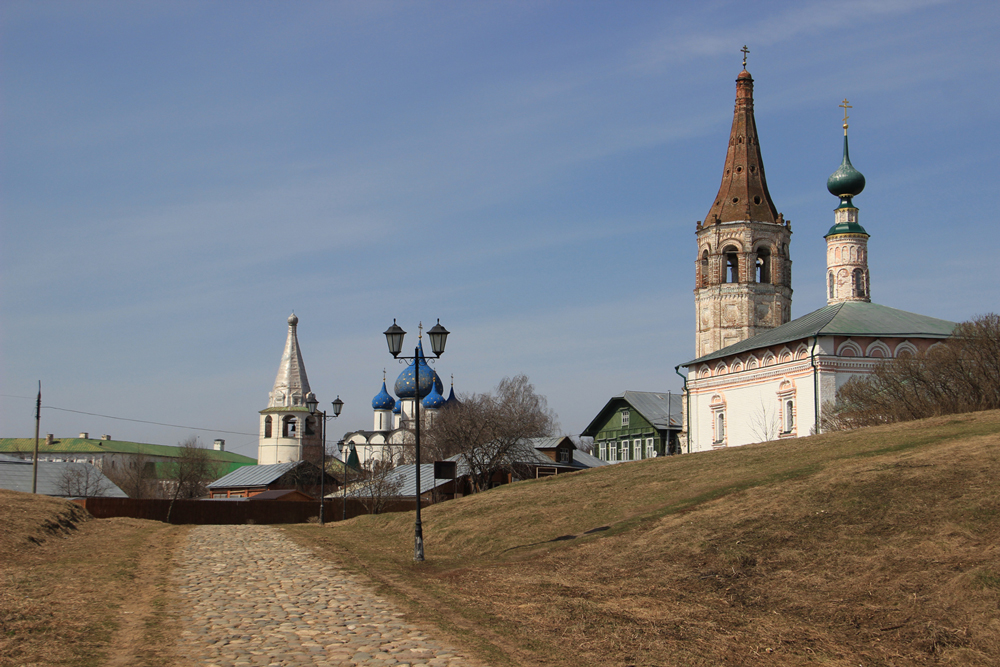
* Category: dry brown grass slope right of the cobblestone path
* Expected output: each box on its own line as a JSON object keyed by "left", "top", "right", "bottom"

{"left": 290, "top": 412, "right": 1000, "bottom": 667}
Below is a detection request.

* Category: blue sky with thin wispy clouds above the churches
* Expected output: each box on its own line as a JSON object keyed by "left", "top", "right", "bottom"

{"left": 0, "top": 1, "right": 1000, "bottom": 456}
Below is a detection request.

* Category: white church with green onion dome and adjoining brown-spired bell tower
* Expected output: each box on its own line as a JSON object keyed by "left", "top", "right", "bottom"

{"left": 678, "top": 61, "right": 955, "bottom": 452}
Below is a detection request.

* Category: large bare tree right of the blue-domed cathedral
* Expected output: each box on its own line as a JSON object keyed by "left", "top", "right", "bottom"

{"left": 427, "top": 375, "right": 556, "bottom": 491}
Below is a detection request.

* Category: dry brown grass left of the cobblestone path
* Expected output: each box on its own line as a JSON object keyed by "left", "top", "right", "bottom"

{"left": 0, "top": 490, "right": 183, "bottom": 667}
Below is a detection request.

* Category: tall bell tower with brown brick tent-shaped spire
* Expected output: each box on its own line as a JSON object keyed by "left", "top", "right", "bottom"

{"left": 694, "top": 46, "right": 792, "bottom": 356}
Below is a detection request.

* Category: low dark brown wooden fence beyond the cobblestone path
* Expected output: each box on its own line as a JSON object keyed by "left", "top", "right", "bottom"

{"left": 74, "top": 498, "right": 416, "bottom": 525}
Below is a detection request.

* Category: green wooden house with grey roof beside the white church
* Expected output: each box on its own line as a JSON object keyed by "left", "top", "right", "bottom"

{"left": 581, "top": 391, "right": 682, "bottom": 463}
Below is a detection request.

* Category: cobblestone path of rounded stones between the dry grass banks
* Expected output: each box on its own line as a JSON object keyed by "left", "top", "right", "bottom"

{"left": 174, "top": 525, "right": 481, "bottom": 667}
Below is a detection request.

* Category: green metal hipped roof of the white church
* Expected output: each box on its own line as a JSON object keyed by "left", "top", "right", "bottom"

{"left": 680, "top": 301, "right": 956, "bottom": 367}
